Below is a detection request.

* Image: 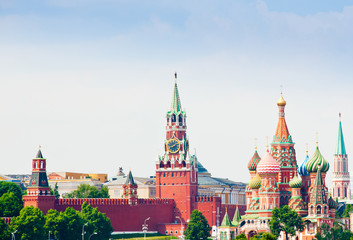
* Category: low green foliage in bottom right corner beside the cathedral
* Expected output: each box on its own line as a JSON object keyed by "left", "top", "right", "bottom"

{"left": 315, "top": 224, "right": 353, "bottom": 240}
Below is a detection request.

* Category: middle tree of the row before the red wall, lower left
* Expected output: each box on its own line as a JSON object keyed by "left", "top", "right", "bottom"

{"left": 57, "top": 207, "right": 84, "bottom": 240}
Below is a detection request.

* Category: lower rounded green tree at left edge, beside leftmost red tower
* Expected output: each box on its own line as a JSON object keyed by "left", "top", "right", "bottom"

{"left": 0, "top": 192, "right": 23, "bottom": 217}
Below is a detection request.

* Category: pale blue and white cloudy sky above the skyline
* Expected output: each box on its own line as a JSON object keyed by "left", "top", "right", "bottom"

{"left": 0, "top": 0, "right": 353, "bottom": 187}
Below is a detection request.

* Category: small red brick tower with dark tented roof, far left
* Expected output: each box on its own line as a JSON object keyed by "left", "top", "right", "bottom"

{"left": 23, "top": 147, "right": 55, "bottom": 214}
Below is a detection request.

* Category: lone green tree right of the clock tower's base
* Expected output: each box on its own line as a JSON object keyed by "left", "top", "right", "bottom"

{"left": 184, "top": 210, "right": 211, "bottom": 240}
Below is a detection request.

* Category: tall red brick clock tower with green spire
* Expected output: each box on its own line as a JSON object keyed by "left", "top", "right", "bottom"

{"left": 156, "top": 73, "right": 198, "bottom": 222}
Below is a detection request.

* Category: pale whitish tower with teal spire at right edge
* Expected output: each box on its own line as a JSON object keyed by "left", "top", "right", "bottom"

{"left": 332, "top": 113, "right": 351, "bottom": 200}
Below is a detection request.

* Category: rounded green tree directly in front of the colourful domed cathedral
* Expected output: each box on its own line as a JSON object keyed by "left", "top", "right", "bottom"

{"left": 269, "top": 205, "right": 304, "bottom": 240}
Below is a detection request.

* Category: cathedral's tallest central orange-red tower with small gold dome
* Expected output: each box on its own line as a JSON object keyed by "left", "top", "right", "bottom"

{"left": 271, "top": 92, "right": 297, "bottom": 206}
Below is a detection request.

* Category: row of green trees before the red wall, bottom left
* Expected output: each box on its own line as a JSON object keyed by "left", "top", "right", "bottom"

{"left": 7, "top": 202, "right": 113, "bottom": 240}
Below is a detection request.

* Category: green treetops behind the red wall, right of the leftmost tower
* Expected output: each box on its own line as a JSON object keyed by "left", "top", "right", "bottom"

{"left": 63, "top": 184, "right": 110, "bottom": 198}
